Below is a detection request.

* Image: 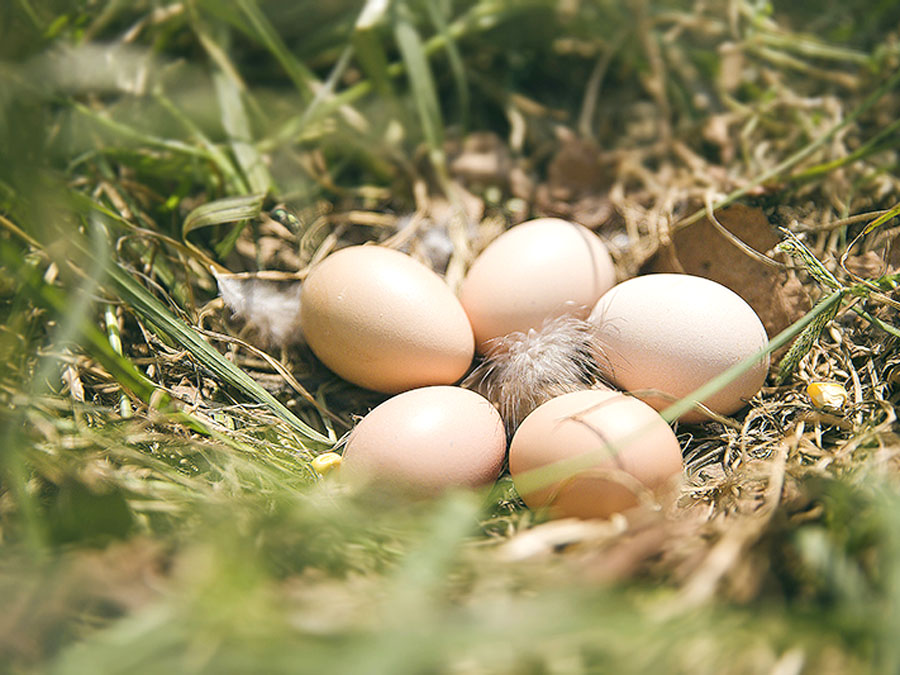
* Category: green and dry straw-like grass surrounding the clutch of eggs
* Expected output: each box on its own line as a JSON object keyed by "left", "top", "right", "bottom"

{"left": 0, "top": 0, "right": 900, "bottom": 673}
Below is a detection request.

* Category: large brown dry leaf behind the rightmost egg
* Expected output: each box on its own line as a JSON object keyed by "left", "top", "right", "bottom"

{"left": 642, "top": 204, "right": 812, "bottom": 337}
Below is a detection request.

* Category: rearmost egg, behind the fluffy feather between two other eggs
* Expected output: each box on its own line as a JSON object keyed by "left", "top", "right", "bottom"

{"left": 460, "top": 218, "right": 616, "bottom": 352}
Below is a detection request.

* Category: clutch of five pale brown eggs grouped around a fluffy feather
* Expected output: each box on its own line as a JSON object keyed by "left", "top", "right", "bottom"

{"left": 292, "top": 218, "right": 768, "bottom": 518}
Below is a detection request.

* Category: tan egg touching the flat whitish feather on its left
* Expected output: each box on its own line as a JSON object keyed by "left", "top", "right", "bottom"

{"left": 300, "top": 246, "right": 475, "bottom": 394}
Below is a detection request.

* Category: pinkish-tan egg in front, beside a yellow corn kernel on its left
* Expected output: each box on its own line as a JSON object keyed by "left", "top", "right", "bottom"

{"left": 341, "top": 386, "right": 506, "bottom": 494}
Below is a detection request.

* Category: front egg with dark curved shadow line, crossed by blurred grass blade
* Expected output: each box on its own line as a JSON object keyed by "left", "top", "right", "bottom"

{"left": 509, "top": 389, "right": 682, "bottom": 518}
